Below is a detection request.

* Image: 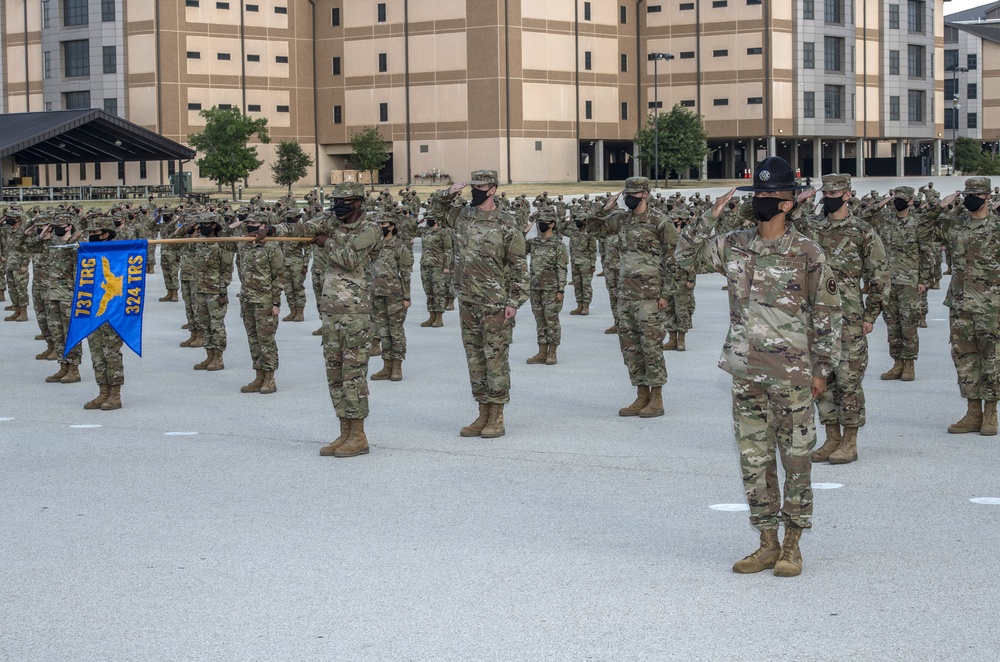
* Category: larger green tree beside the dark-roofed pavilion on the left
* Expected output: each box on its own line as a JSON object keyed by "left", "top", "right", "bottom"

{"left": 188, "top": 106, "right": 271, "bottom": 200}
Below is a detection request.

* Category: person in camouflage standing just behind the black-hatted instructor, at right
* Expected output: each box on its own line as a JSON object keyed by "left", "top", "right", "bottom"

{"left": 799, "top": 174, "right": 889, "bottom": 464}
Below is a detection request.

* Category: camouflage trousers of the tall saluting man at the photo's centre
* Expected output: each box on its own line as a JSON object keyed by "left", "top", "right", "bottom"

{"left": 459, "top": 301, "right": 514, "bottom": 404}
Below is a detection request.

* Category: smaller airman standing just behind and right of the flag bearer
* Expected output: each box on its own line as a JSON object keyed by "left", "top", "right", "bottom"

{"left": 371, "top": 218, "right": 413, "bottom": 382}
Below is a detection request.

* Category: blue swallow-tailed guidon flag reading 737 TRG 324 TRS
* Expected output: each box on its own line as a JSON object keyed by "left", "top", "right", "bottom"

{"left": 66, "top": 239, "right": 146, "bottom": 356}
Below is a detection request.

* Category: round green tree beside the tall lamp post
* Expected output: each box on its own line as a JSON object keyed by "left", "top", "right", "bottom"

{"left": 635, "top": 104, "right": 709, "bottom": 180}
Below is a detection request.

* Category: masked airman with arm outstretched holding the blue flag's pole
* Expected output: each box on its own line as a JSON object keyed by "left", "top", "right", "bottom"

{"left": 271, "top": 182, "right": 382, "bottom": 457}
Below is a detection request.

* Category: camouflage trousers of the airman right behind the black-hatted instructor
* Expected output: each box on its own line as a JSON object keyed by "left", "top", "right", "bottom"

{"left": 816, "top": 324, "right": 868, "bottom": 428}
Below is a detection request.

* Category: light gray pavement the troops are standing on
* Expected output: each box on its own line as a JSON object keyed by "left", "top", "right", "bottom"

{"left": 0, "top": 187, "right": 1000, "bottom": 662}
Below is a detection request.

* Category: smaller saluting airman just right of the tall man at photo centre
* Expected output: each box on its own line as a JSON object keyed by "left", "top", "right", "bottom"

{"left": 525, "top": 208, "right": 569, "bottom": 365}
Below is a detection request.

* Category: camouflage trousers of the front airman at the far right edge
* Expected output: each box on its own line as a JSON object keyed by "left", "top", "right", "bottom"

{"left": 951, "top": 309, "right": 1000, "bottom": 401}
